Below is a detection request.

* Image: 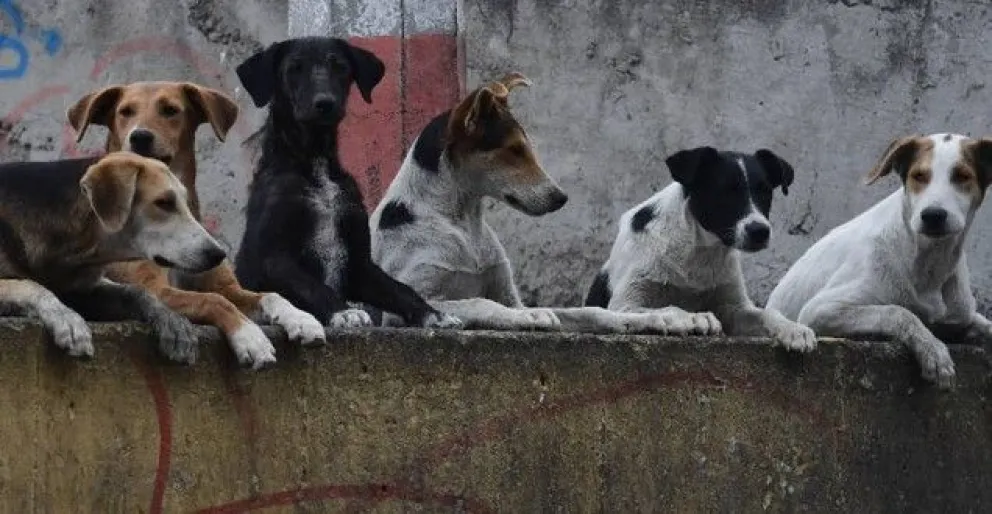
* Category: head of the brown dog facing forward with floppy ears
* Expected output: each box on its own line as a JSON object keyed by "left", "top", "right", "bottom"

{"left": 66, "top": 82, "right": 238, "bottom": 164}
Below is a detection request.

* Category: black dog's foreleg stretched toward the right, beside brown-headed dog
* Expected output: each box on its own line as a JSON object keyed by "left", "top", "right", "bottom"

{"left": 348, "top": 260, "right": 463, "bottom": 329}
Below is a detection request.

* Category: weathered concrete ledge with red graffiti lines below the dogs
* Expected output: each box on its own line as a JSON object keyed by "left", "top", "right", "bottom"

{"left": 0, "top": 320, "right": 992, "bottom": 513}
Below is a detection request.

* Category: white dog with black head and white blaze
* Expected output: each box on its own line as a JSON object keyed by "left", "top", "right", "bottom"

{"left": 586, "top": 146, "right": 816, "bottom": 351}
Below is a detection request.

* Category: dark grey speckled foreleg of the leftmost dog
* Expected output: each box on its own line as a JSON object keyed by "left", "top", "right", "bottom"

{"left": 63, "top": 279, "right": 197, "bottom": 364}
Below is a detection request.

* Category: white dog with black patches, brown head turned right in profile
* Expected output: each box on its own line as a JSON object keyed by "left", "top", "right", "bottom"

{"left": 370, "top": 73, "right": 704, "bottom": 334}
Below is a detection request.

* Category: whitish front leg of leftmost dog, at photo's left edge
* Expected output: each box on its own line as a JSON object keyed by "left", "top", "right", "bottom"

{"left": 0, "top": 279, "right": 93, "bottom": 357}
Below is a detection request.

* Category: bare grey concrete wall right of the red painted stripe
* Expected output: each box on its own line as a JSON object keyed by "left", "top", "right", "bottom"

{"left": 459, "top": 0, "right": 992, "bottom": 312}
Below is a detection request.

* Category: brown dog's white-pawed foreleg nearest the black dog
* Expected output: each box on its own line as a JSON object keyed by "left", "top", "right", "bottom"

{"left": 193, "top": 261, "right": 326, "bottom": 345}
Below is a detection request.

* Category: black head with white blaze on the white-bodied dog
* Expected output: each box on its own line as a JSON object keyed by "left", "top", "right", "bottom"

{"left": 665, "top": 146, "right": 794, "bottom": 252}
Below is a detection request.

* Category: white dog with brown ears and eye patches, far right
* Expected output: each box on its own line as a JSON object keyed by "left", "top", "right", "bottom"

{"left": 768, "top": 134, "right": 992, "bottom": 388}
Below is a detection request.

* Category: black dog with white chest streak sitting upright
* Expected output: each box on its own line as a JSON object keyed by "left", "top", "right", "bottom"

{"left": 235, "top": 37, "right": 461, "bottom": 328}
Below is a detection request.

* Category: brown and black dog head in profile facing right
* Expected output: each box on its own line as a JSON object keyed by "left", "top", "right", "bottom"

{"left": 445, "top": 73, "right": 568, "bottom": 216}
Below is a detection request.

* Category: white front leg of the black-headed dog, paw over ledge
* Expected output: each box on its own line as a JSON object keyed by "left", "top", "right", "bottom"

{"left": 716, "top": 304, "right": 816, "bottom": 352}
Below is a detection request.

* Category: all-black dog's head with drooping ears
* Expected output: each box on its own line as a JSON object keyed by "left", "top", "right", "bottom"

{"left": 237, "top": 37, "right": 386, "bottom": 125}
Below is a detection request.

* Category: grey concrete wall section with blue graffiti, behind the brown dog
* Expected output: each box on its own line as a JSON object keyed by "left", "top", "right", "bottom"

{"left": 0, "top": 0, "right": 287, "bottom": 252}
